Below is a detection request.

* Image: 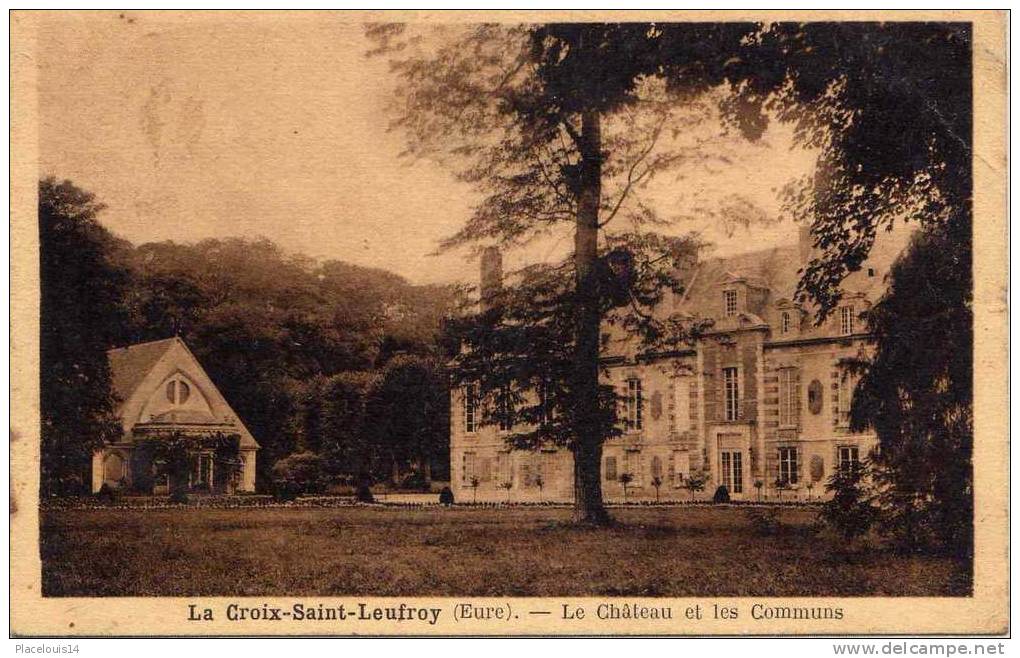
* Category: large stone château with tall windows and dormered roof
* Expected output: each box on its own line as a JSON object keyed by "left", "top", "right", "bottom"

{"left": 450, "top": 225, "right": 909, "bottom": 502}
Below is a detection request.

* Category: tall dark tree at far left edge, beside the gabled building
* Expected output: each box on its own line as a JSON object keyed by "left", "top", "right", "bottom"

{"left": 39, "top": 179, "right": 129, "bottom": 496}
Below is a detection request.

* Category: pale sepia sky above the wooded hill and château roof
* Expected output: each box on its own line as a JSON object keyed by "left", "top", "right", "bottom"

{"left": 38, "top": 11, "right": 814, "bottom": 284}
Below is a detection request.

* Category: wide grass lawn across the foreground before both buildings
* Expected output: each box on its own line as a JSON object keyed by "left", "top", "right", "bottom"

{"left": 41, "top": 507, "right": 970, "bottom": 596}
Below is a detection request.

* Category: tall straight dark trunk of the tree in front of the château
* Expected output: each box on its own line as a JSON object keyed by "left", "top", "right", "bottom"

{"left": 571, "top": 111, "right": 609, "bottom": 524}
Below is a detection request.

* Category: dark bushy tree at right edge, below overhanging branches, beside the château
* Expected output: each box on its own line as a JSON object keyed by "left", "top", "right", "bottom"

{"left": 851, "top": 227, "right": 974, "bottom": 557}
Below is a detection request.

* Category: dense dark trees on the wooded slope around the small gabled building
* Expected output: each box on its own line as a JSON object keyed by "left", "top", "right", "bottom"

{"left": 39, "top": 174, "right": 455, "bottom": 493}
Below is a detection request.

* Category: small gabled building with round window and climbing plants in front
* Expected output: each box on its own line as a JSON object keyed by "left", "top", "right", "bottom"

{"left": 92, "top": 338, "right": 259, "bottom": 493}
